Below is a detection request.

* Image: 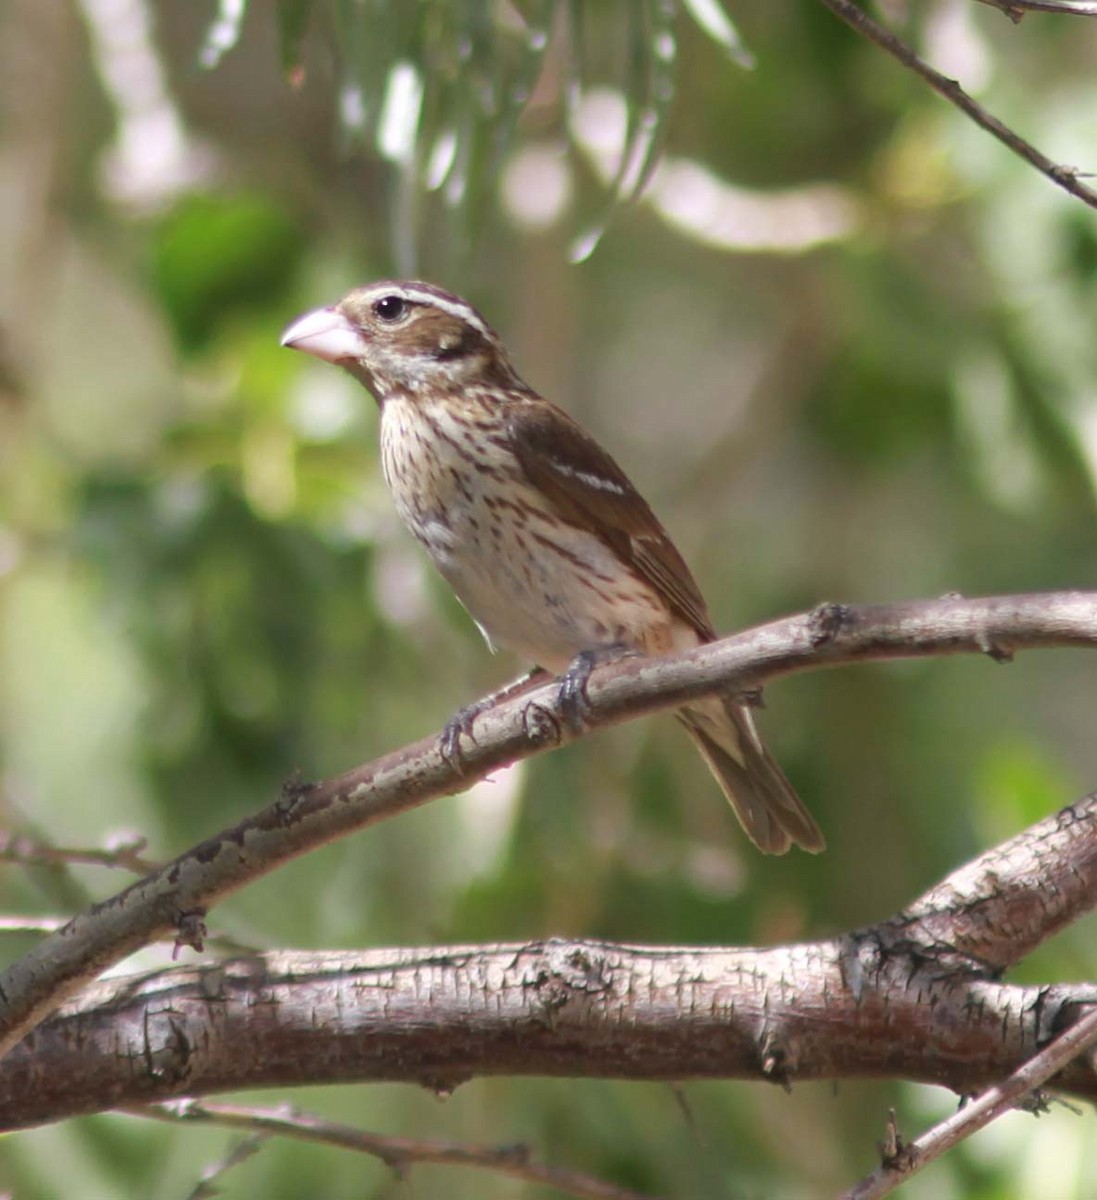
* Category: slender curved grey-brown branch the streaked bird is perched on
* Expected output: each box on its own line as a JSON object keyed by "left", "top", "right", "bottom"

{"left": 0, "top": 592, "right": 1097, "bottom": 1052}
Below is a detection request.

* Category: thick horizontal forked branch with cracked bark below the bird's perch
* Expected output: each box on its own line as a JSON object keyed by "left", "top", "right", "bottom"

{"left": 0, "top": 796, "right": 1097, "bottom": 1128}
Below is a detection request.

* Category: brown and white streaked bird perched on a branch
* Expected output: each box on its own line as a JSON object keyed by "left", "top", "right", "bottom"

{"left": 282, "top": 281, "right": 825, "bottom": 854}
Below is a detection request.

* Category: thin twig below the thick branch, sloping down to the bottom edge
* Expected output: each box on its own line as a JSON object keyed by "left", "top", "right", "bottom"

{"left": 128, "top": 1099, "right": 655, "bottom": 1200}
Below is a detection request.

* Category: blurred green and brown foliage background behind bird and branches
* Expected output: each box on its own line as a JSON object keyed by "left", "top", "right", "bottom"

{"left": 0, "top": 0, "right": 1097, "bottom": 1200}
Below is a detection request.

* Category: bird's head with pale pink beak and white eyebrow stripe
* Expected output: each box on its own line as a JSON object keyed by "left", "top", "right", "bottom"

{"left": 282, "top": 280, "right": 523, "bottom": 403}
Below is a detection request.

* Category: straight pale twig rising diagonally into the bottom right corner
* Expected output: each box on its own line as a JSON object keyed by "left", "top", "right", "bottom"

{"left": 841, "top": 1009, "right": 1097, "bottom": 1200}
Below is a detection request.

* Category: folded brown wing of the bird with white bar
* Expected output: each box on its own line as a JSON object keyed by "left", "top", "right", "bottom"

{"left": 509, "top": 398, "right": 715, "bottom": 641}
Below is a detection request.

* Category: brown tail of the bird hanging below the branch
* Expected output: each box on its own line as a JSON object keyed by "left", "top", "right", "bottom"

{"left": 678, "top": 696, "right": 827, "bottom": 854}
